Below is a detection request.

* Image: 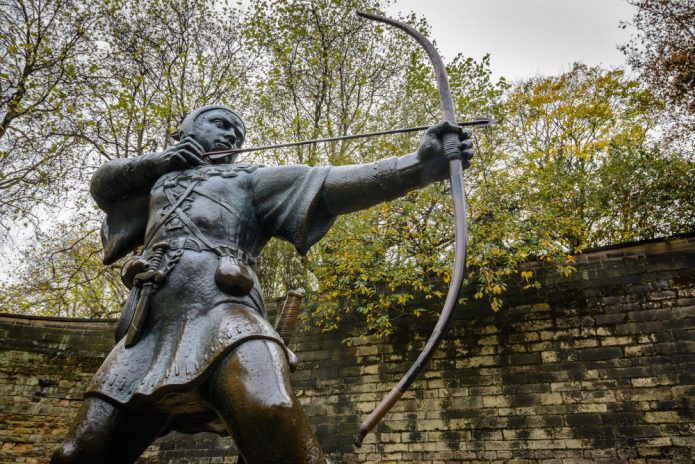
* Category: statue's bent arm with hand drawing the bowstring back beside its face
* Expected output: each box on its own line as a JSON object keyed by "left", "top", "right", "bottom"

{"left": 90, "top": 138, "right": 204, "bottom": 210}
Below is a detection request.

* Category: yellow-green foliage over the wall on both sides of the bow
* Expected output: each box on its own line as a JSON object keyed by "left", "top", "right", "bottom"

{"left": 310, "top": 62, "right": 695, "bottom": 337}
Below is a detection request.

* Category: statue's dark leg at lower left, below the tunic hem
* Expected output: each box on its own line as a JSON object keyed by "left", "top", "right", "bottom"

{"left": 51, "top": 397, "right": 167, "bottom": 464}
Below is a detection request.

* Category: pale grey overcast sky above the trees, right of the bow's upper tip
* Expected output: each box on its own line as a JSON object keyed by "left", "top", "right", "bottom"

{"left": 387, "top": 0, "right": 634, "bottom": 80}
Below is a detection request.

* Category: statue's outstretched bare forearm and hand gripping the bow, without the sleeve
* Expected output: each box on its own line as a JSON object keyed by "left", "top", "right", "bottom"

{"left": 322, "top": 122, "right": 472, "bottom": 215}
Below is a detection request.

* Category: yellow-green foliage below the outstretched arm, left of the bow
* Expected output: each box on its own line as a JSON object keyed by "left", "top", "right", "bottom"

{"left": 309, "top": 184, "right": 460, "bottom": 337}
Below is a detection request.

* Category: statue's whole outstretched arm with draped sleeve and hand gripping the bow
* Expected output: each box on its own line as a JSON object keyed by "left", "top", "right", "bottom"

{"left": 251, "top": 123, "right": 472, "bottom": 254}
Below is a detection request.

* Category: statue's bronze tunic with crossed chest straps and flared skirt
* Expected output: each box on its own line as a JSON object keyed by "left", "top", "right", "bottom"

{"left": 85, "top": 164, "right": 335, "bottom": 432}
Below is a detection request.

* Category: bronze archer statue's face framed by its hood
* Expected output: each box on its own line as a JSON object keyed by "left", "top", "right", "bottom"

{"left": 193, "top": 109, "right": 244, "bottom": 161}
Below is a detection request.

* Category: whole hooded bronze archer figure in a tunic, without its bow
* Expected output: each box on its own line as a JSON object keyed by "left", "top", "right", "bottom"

{"left": 51, "top": 10, "right": 472, "bottom": 464}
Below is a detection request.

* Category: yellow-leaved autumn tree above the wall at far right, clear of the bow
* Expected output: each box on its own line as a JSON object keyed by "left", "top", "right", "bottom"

{"left": 508, "top": 65, "right": 693, "bottom": 248}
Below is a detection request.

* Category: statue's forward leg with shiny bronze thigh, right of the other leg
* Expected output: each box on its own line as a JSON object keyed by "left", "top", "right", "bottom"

{"left": 207, "top": 340, "right": 326, "bottom": 464}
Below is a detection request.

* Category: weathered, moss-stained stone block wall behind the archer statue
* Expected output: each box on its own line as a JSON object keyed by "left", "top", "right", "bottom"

{"left": 0, "top": 237, "right": 695, "bottom": 464}
